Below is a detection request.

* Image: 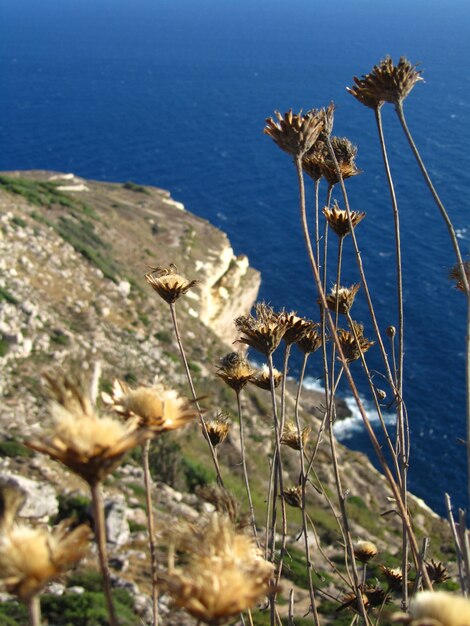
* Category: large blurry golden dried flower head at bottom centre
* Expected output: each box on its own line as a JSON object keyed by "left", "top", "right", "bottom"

{"left": 162, "top": 514, "right": 273, "bottom": 626}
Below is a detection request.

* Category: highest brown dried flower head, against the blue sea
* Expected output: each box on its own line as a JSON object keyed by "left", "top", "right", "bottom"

{"left": 346, "top": 56, "right": 423, "bottom": 109}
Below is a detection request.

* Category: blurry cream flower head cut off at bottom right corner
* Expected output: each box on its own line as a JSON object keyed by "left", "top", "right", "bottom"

{"left": 393, "top": 591, "right": 470, "bottom": 626}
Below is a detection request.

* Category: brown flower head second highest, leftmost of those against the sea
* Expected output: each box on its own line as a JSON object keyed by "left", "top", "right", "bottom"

{"left": 264, "top": 109, "right": 325, "bottom": 157}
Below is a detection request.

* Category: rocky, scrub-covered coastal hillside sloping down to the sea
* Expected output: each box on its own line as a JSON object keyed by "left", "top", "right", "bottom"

{"left": 0, "top": 171, "right": 455, "bottom": 625}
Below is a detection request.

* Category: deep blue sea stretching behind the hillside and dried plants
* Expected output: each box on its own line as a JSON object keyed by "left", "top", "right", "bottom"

{"left": 0, "top": 0, "right": 470, "bottom": 514}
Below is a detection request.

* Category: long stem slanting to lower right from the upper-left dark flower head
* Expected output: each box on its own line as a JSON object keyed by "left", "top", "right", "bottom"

{"left": 295, "top": 152, "right": 432, "bottom": 588}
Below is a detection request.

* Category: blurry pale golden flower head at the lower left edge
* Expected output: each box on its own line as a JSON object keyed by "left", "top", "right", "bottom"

{"left": 0, "top": 522, "right": 91, "bottom": 602}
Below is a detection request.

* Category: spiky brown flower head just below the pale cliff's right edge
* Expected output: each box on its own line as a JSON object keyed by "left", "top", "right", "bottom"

{"left": 235, "top": 302, "right": 286, "bottom": 355}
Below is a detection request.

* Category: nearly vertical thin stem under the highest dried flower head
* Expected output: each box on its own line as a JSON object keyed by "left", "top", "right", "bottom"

{"left": 374, "top": 107, "right": 409, "bottom": 611}
